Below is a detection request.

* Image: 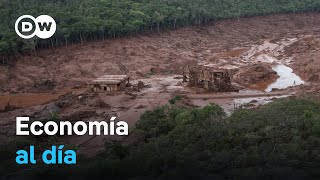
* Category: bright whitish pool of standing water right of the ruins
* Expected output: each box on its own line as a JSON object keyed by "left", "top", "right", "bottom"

{"left": 265, "top": 64, "right": 305, "bottom": 92}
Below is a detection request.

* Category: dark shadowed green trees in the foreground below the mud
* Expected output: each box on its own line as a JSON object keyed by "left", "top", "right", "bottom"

{"left": 0, "top": 97, "right": 320, "bottom": 179}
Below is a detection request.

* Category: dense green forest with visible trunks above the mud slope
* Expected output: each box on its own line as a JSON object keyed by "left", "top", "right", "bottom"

{"left": 0, "top": 0, "right": 320, "bottom": 58}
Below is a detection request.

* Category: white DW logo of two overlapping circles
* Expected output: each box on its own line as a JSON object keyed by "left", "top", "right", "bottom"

{"left": 15, "top": 15, "right": 57, "bottom": 39}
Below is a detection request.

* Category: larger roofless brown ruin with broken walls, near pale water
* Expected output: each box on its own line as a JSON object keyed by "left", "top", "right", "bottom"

{"left": 183, "top": 65, "right": 238, "bottom": 92}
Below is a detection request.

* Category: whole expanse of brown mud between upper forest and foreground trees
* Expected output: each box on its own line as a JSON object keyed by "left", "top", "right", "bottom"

{"left": 0, "top": 13, "right": 320, "bottom": 153}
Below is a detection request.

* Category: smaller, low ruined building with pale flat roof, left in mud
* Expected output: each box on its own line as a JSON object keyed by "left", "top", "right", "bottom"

{"left": 90, "top": 75, "right": 130, "bottom": 92}
